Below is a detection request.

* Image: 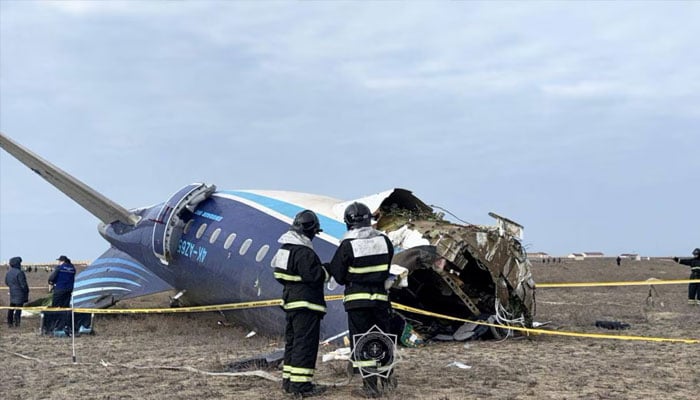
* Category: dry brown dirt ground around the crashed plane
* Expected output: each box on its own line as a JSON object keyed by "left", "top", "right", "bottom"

{"left": 0, "top": 259, "right": 700, "bottom": 400}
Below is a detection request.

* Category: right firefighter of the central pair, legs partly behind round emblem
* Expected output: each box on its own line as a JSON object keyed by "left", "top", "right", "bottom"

{"left": 329, "top": 202, "right": 396, "bottom": 398}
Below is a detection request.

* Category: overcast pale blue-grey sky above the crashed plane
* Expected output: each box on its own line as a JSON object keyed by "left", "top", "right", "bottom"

{"left": 0, "top": 0, "right": 700, "bottom": 262}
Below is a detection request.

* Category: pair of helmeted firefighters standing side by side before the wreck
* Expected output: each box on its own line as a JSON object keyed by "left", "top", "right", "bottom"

{"left": 272, "top": 202, "right": 396, "bottom": 398}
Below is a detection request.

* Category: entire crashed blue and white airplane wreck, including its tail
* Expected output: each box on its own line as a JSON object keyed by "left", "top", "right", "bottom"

{"left": 0, "top": 134, "right": 535, "bottom": 344}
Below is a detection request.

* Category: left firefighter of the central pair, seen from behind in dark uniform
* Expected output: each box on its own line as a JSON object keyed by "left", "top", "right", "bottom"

{"left": 272, "top": 210, "right": 328, "bottom": 398}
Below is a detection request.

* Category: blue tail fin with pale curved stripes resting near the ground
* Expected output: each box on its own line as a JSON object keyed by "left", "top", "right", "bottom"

{"left": 73, "top": 247, "right": 174, "bottom": 308}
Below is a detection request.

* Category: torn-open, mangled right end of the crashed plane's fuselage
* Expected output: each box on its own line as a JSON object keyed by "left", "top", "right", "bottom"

{"left": 375, "top": 191, "right": 535, "bottom": 345}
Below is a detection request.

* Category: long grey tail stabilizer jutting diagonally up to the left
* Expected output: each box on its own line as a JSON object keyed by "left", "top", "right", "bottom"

{"left": 0, "top": 132, "right": 139, "bottom": 225}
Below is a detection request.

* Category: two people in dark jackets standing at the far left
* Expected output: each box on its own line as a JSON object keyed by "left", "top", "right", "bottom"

{"left": 5, "top": 256, "right": 75, "bottom": 328}
